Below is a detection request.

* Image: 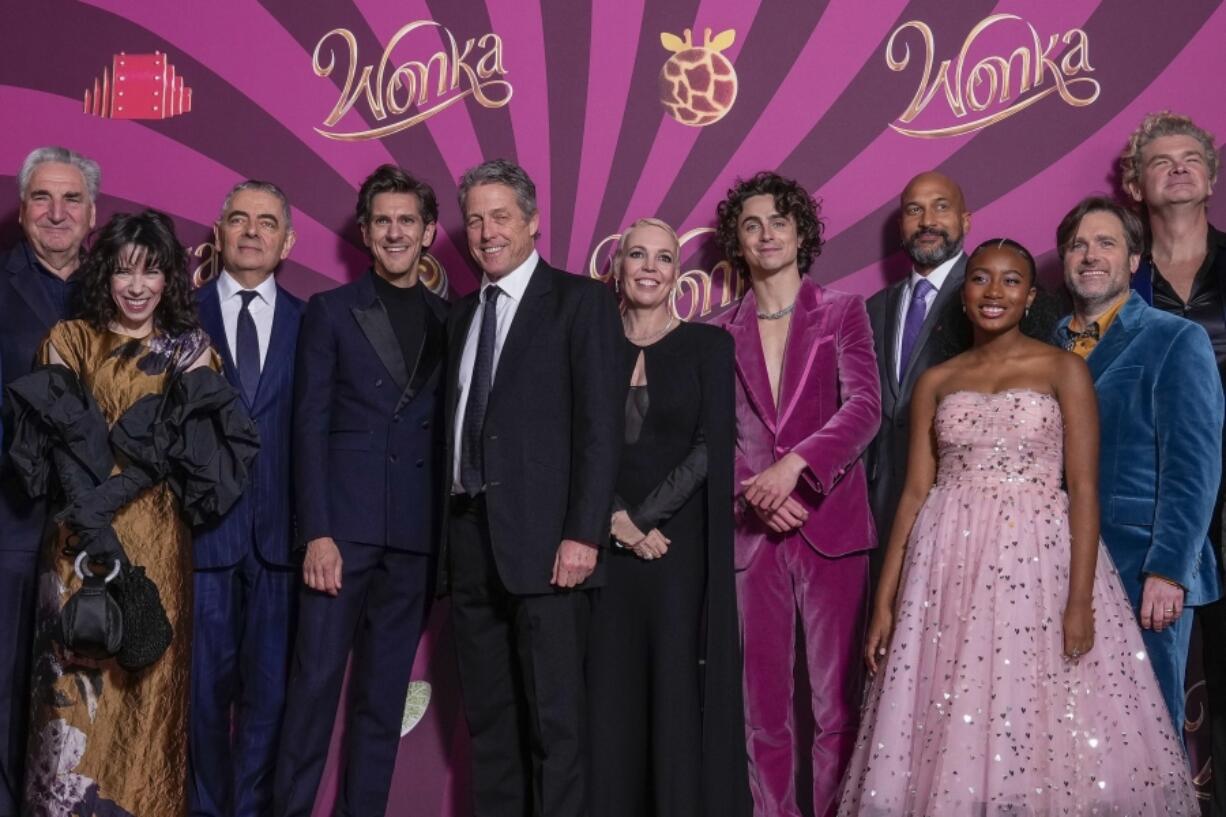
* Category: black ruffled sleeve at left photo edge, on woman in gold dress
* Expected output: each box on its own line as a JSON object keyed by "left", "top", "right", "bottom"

{"left": 5, "top": 363, "right": 114, "bottom": 497}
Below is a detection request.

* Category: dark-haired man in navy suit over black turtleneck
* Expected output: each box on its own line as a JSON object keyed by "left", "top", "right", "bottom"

{"left": 273, "top": 164, "right": 446, "bottom": 817}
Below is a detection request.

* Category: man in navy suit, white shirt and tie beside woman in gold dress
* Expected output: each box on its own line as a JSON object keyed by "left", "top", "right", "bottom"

{"left": 188, "top": 179, "right": 303, "bottom": 817}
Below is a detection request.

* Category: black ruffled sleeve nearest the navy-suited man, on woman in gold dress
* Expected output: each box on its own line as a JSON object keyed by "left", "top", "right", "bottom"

{"left": 112, "top": 367, "right": 260, "bottom": 525}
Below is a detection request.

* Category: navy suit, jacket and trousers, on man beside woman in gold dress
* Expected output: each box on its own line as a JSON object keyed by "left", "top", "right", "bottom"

{"left": 189, "top": 281, "right": 303, "bottom": 817}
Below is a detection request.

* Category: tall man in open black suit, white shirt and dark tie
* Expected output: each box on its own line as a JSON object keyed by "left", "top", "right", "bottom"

{"left": 440, "top": 159, "right": 626, "bottom": 817}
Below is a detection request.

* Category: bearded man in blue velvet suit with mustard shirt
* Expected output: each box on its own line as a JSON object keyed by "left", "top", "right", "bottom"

{"left": 1056, "top": 198, "right": 1224, "bottom": 731}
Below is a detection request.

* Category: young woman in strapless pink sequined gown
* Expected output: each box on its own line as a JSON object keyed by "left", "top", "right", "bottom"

{"left": 839, "top": 239, "right": 1199, "bottom": 817}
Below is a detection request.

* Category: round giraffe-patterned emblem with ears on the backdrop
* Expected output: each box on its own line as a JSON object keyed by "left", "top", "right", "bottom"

{"left": 660, "top": 28, "right": 737, "bottom": 128}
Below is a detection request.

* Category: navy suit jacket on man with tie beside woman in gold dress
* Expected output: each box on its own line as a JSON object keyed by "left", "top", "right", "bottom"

{"left": 192, "top": 281, "right": 304, "bottom": 568}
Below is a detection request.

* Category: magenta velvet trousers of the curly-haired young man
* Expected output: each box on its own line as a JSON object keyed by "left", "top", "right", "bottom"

{"left": 737, "top": 534, "right": 868, "bottom": 817}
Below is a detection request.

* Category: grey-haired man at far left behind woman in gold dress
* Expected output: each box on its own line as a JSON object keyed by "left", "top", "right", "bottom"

{"left": 0, "top": 147, "right": 102, "bottom": 817}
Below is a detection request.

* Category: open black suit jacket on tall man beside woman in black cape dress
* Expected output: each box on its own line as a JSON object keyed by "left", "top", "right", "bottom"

{"left": 439, "top": 261, "right": 628, "bottom": 595}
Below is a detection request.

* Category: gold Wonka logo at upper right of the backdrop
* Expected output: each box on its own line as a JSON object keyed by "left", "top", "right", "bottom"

{"left": 885, "top": 13, "right": 1101, "bottom": 139}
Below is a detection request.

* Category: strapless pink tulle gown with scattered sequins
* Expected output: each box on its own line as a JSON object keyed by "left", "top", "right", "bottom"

{"left": 839, "top": 390, "right": 1199, "bottom": 817}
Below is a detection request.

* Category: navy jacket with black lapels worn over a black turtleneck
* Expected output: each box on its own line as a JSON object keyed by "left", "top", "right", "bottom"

{"left": 294, "top": 271, "right": 447, "bottom": 553}
